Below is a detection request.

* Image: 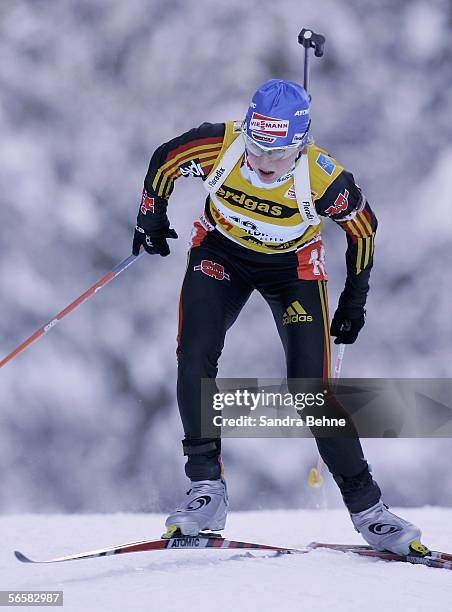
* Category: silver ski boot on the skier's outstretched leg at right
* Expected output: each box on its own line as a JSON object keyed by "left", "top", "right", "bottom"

{"left": 350, "top": 501, "right": 428, "bottom": 555}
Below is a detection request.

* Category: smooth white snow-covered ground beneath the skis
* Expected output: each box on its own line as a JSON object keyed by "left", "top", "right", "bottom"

{"left": 0, "top": 507, "right": 452, "bottom": 612}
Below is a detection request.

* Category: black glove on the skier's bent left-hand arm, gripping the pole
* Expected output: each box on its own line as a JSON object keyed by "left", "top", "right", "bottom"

{"left": 132, "top": 189, "right": 178, "bottom": 257}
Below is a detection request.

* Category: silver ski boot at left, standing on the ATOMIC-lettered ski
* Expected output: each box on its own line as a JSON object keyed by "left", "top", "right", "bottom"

{"left": 165, "top": 480, "right": 228, "bottom": 536}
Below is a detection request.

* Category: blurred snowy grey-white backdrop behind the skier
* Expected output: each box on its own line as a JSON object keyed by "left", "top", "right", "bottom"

{"left": 0, "top": 0, "right": 452, "bottom": 513}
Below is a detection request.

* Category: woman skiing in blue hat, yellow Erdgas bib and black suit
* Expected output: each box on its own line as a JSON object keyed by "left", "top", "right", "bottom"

{"left": 133, "top": 79, "right": 423, "bottom": 554}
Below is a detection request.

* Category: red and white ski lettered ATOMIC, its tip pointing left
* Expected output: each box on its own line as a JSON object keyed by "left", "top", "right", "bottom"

{"left": 14, "top": 532, "right": 300, "bottom": 563}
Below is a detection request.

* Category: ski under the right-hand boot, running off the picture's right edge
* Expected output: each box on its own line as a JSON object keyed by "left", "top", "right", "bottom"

{"left": 308, "top": 542, "right": 452, "bottom": 570}
